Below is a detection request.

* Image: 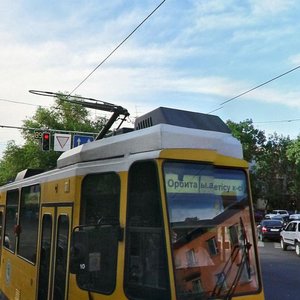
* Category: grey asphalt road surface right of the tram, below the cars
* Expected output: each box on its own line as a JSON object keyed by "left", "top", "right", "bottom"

{"left": 258, "top": 241, "right": 300, "bottom": 300}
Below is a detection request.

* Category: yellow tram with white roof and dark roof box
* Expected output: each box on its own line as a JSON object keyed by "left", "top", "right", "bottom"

{"left": 0, "top": 108, "right": 264, "bottom": 300}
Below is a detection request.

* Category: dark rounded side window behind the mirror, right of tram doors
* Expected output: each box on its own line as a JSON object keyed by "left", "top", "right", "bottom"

{"left": 76, "top": 172, "right": 121, "bottom": 295}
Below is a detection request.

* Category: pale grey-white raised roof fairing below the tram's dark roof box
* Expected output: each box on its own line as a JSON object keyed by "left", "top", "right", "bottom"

{"left": 57, "top": 124, "right": 243, "bottom": 168}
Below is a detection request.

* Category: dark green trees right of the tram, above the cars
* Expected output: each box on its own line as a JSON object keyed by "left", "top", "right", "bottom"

{"left": 227, "top": 120, "right": 300, "bottom": 209}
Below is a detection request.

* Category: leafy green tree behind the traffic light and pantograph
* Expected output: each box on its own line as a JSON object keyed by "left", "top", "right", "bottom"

{"left": 0, "top": 95, "right": 107, "bottom": 184}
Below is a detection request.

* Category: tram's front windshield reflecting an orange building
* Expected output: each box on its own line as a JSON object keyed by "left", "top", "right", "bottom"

{"left": 164, "top": 162, "right": 259, "bottom": 300}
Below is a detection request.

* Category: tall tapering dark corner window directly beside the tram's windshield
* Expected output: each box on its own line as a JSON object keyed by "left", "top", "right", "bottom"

{"left": 124, "top": 161, "right": 170, "bottom": 300}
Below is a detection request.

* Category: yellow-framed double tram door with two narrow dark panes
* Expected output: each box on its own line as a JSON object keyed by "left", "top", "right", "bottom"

{"left": 37, "top": 206, "right": 72, "bottom": 300}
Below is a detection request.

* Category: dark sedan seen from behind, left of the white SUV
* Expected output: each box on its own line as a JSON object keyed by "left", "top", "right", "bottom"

{"left": 257, "top": 219, "right": 284, "bottom": 241}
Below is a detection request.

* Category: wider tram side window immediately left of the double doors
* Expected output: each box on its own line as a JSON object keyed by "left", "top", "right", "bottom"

{"left": 18, "top": 185, "right": 40, "bottom": 263}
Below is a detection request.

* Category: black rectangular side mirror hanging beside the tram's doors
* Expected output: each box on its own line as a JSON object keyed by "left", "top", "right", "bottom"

{"left": 70, "top": 231, "right": 89, "bottom": 274}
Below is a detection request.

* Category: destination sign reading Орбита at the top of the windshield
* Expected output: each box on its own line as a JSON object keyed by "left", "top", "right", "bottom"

{"left": 166, "top": 174, "right": 245, "bottom": 196}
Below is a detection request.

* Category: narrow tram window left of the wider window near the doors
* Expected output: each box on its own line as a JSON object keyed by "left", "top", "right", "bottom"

{"left": 3, "top": 190, "right": 19, "bottom": 252}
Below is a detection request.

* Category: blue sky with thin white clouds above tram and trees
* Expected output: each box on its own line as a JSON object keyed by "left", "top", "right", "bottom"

{"left": 0, "top": 0, "right": 300, "bottom": 157}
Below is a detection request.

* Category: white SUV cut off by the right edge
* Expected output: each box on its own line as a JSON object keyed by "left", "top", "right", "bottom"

{"left": 280, "top": 220, "right": 300, "bottom": 256}
